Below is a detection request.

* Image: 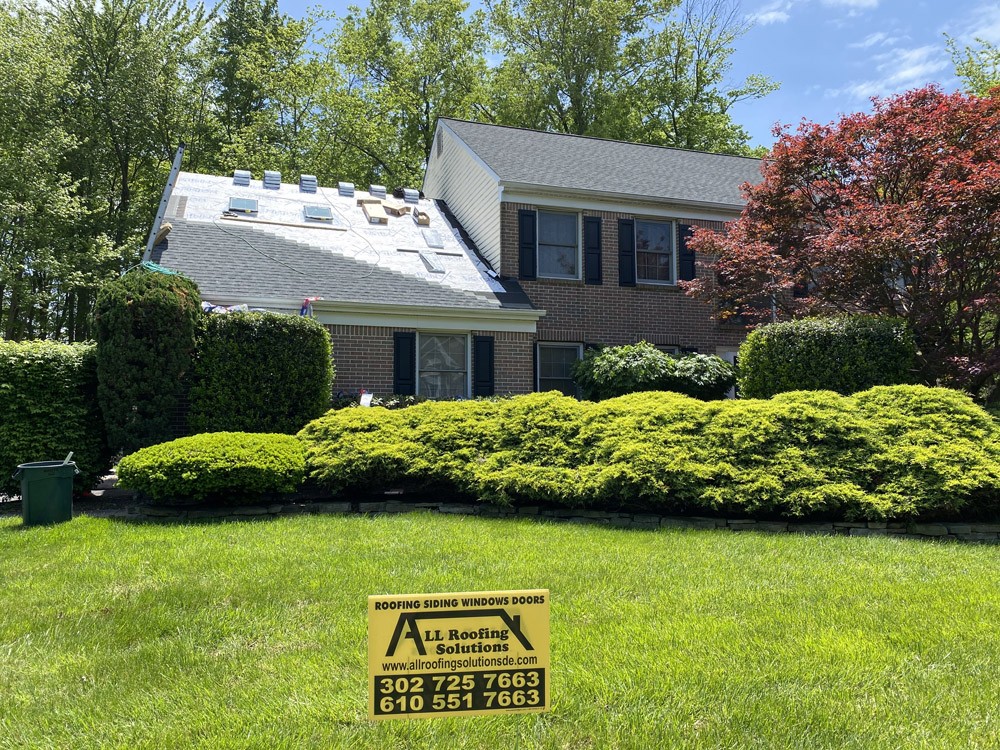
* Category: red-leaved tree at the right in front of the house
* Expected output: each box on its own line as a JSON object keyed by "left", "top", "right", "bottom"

{"left": 687, "top": 86, "right": 1000, "bottom": 397}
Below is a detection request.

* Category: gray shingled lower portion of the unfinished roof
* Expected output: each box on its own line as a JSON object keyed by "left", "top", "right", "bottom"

{"left": 152, "top": 218, "right": 512, "bottom": 310}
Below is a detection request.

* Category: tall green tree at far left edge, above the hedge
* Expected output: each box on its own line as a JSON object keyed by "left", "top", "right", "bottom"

{"left": 0, "top": 5, "right": 113, "bottom": 340}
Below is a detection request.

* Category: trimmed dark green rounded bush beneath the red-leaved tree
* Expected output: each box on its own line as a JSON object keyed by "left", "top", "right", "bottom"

{"left": 738, "top": 315, "right": 916, "bottom": 398}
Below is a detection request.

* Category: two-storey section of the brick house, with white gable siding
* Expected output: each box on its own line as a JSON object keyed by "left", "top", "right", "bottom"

{"left": 423, "top": 119, "right": 761, "bottom": 392}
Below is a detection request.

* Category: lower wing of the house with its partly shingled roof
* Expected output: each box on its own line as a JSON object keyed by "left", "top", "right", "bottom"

{"left": 148, "top": 170, "right": 544, "bottom": 398}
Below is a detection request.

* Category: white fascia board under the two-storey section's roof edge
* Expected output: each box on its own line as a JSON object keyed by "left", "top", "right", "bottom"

{"left": 501, "top": 183, "right": 743, "bottom": 221}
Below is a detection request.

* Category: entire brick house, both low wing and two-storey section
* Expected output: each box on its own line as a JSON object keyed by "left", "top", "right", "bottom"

{"left": 147, "top": 119, "right": 760, "bottom": 397}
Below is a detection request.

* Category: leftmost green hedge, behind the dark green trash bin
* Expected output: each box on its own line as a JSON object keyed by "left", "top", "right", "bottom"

{"left": 0, "top": 341, "right": 110, "bottom": 494}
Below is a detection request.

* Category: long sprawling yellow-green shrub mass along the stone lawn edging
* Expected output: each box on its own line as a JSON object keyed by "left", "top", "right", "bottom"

{"left": 300, "top": 386, "right": 1000, "bottom": 519}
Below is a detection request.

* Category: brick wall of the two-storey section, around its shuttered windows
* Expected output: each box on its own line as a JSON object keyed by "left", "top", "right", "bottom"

{"left": 501, "top": 203, "right": 746, "bottom": 354}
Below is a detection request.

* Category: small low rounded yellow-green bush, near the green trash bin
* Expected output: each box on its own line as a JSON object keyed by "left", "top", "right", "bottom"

{"left": 118, "top": 432, "right": 305, "bottom": 503}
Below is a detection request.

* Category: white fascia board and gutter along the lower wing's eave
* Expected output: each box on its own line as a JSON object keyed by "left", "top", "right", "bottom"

{"left": 194, "top": 296, "right": 545, "bottom": 333}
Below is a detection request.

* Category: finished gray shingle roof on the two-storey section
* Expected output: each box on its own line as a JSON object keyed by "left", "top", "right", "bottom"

{"left": 441, "top": 118, "right": 761, "bottom": 207}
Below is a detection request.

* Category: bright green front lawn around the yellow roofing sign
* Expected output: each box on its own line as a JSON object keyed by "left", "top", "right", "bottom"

{"left": 0, "top": 514, "right": 1000, "bottom": 750}
